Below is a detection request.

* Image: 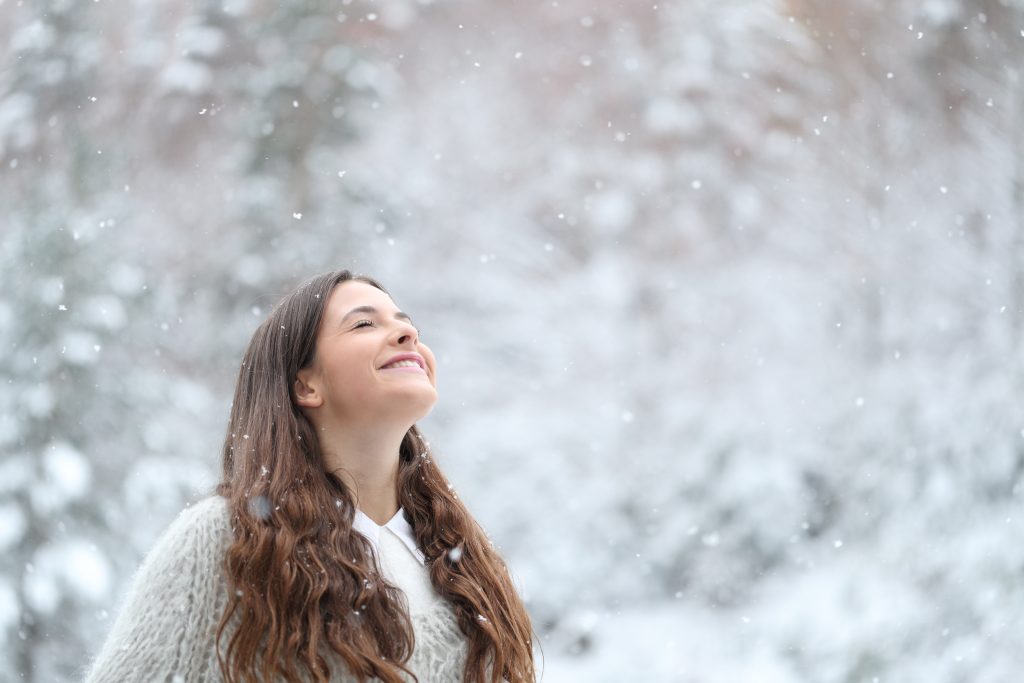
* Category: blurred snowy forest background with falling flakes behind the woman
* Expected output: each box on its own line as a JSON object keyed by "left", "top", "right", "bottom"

{"left": 0, "top": 0, "right": 1024, "bottom": 683}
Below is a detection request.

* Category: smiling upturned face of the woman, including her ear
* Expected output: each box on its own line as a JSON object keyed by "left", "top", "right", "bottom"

{"left": 296, "top": 281, "right": 437, "bottom": 426}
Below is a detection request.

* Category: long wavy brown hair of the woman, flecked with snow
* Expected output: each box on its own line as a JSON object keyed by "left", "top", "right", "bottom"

{"left": 217, "top": 270, "right": 536, "bottom": 683}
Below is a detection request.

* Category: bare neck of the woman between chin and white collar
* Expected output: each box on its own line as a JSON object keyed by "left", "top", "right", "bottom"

{"left": 317, "top": 426, "right": 409, "bottom": 524}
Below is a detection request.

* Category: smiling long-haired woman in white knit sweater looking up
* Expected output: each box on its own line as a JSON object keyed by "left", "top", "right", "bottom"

{"left": 81, "top": 270, "right": 535, "bottom": 683}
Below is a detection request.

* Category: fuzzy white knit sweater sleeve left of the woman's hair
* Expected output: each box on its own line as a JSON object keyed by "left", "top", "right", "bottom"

{"left": 85, "top": 496, "right": 231, "bottom": 683}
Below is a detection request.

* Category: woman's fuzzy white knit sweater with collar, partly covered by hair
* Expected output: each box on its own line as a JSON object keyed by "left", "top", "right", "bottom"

{"left": 86, "top": 496, "right": 467, "bottom": 683}
